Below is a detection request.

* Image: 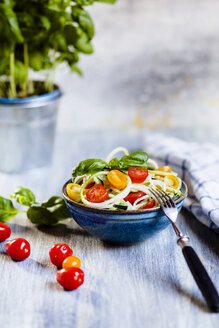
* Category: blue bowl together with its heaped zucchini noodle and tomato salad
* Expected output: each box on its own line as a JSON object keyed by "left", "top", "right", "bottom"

{"left": 62, "top": 147, "right": 187, "bottom": 243}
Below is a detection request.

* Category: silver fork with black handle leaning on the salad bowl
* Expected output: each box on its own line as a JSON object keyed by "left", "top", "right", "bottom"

{"left": 150, "top": 189, "right": 219, "bottom": 312}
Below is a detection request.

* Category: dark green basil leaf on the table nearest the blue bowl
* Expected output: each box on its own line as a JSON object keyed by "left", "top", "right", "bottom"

{"left": 27, "top": 196, "right": 71, "bottom": 225}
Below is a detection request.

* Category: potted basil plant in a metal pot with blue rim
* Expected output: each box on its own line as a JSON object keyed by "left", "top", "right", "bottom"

{"left": 0, "top": 0, "right": 116, "bottom": 172}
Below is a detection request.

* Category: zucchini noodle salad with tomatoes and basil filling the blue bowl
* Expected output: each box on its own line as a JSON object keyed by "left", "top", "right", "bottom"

{"left": 66, "top": 147, "right": 182, "bottom": 211}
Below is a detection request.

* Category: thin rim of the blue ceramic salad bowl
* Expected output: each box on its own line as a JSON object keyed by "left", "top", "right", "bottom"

{"left": 62, "top": 179, "right": 188, "bottom": 215}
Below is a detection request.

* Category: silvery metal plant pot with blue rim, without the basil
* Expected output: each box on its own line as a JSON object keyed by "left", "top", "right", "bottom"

{"left": 0, "top": 89, "right": 61, "bottom": 173}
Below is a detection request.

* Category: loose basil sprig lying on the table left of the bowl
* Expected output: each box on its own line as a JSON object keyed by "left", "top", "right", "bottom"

{"left": 0, "top": 187, "right": 71, "bottom": 225}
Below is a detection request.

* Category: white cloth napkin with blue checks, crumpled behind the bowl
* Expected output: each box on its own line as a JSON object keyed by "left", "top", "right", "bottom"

{"left": 144, "top": 134, "right": 219, "bottom": 233}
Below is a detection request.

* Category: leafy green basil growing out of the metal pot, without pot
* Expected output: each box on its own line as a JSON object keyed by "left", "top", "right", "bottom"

{"left": 0, "top": 0, "right": 116, "bottom": 98}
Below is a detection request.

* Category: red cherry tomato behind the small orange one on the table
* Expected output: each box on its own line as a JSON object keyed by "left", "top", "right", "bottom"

{"left": 49, "top": 244, "right": 73, "bottom": 267}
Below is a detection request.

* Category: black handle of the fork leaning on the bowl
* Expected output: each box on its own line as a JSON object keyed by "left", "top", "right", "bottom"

{"left": 182, "top": 246, "right": 219, "bottom": 312}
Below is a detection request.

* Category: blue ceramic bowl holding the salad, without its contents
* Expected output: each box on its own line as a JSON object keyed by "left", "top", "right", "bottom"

{"left": 62, "top": 180, "right": 187, "bottom": 243}
